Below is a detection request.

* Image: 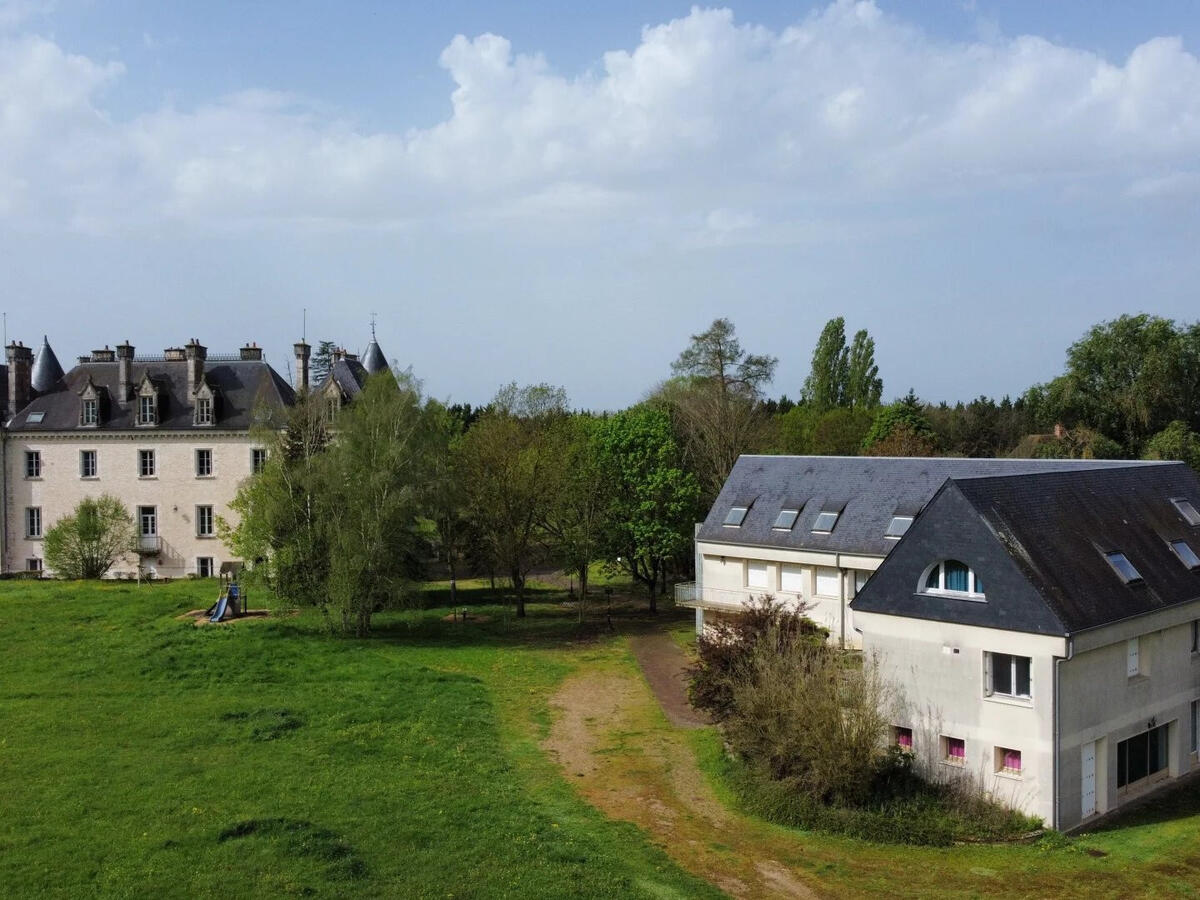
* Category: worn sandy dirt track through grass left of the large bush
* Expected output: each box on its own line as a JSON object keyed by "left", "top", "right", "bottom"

{"left": 544, "top": 662, "right": 817, "bottom": 899}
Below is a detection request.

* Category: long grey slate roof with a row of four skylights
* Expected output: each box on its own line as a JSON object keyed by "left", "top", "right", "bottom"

{"left": 696, "top": 456, "right": 1164, "bottom": 557}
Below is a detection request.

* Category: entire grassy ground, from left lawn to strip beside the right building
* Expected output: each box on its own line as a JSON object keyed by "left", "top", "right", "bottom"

{"left": 7, "top": 582, "right": 1200, "bottom": 898}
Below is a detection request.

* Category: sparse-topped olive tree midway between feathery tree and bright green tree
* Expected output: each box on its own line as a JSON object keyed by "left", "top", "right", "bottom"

{"left": 460, "top": 384, "right": 566, "bottom": 618}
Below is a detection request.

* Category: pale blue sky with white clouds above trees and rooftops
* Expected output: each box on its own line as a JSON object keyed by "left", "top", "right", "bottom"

{"left": 0, "top": 0, "right": 1200, "bottom": 408}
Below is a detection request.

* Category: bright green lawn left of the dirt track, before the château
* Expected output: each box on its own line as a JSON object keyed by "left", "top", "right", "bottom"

{"left": 0, "top": 582, "right": 715, "bottom": 898}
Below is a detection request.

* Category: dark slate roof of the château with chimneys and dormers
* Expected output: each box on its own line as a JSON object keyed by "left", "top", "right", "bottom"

{"left": 8, "top": 360, "right": 295, "bottom": 432}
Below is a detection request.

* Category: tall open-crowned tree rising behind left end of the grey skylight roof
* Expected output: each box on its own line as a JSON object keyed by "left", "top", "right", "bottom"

{"left": 655, "top": 319, "right": 779, "bottom": 497}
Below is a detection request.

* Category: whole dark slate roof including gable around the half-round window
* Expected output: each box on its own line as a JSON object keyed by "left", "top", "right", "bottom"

{"left": 851, "top": 463, "right": 1200, "bottom": 635}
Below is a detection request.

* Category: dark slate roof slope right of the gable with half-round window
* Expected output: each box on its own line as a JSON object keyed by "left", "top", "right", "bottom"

{"left": 953, "top": 463, "right": 1200, "bottom": 631}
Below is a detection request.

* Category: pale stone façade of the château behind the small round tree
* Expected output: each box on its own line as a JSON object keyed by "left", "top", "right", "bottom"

{"left": 4, "top": 430, "right": 260, "bottom": 577}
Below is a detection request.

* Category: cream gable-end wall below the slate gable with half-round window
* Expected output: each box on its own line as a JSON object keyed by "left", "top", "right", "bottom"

{"left": 856, "top": 612, "right": 1066, "bottom": 823}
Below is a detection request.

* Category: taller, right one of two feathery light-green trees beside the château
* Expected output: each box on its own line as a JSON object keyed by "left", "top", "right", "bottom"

{"left": 326, "top": 373, "right": 437, "bottom": 637}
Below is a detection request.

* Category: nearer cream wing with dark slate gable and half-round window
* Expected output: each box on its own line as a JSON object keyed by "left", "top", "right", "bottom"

{"left": 851, "top": 463, "right": 1200, "bottom": 829}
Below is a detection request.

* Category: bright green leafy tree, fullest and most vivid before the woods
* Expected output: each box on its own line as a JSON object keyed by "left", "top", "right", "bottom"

{"left": 599, "top": 407, "right": 700, "bottom": 612}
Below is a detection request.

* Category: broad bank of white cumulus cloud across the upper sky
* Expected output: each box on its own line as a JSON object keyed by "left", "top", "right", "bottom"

{"left": 0, "top": 0, "right": 1200, "bottom": 233}
